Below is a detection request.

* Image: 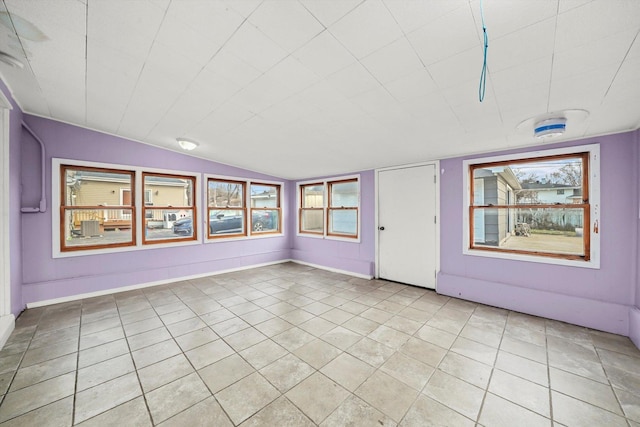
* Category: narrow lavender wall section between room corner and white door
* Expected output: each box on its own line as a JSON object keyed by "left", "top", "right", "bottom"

{"left": 289, "top": 171, "right": 375, "bottom": 277}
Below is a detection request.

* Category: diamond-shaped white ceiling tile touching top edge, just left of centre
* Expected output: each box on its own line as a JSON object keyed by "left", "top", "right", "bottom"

{"left": 248, "top": 1, "right": 324, "bottom": 52}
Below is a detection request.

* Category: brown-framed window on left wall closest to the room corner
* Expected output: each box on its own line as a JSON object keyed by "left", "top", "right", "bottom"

{"left": 251, "top": 183, "right": 281, "bottom": 234}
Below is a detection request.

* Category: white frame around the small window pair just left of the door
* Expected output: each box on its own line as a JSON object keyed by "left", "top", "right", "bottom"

{"left": 296, "top": 174, "right": 362, "bottom": 243}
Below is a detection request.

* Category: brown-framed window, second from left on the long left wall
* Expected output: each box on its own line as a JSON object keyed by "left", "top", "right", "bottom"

{"left": 142, "top": 172, "right": 198, "bottom": 244}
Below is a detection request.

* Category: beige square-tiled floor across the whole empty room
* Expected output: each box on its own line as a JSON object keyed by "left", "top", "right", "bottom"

{"left": 0, "top": 263, "right": 640, "bottom": 427}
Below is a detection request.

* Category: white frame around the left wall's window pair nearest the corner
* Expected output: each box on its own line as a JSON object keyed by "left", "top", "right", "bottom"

{"left": 201, "top": 174, "right": 286, "bottom": 243}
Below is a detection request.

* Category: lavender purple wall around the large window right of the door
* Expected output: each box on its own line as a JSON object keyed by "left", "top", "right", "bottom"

{"left": 437, "top": 132, "right": 639, "bottom": 335}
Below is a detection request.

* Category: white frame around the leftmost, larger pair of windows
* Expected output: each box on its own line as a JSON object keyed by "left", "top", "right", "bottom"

{"left": 51, "top": 158, "right": 202, "bottom": 258}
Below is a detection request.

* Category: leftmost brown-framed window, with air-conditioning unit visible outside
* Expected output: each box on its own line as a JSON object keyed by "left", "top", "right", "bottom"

{"left": 60, "top": 165, "right": 136, "bottom": 252}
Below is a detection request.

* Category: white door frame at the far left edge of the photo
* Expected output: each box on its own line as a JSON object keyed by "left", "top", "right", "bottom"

{"left": 0, "top": 91, "right": 15, "bottom": 348}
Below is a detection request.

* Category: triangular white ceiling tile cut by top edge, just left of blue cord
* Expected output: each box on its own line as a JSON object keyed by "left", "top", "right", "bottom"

{"left": 383, "top": 0, "right": 469, "bottom": 33}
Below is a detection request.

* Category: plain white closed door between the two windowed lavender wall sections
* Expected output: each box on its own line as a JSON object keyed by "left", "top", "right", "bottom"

{"left": 378, "top": 164, "right": 437, "bottom": 289}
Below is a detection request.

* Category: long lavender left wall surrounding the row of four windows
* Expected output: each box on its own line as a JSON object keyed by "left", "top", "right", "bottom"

{"left": 15, "top": 115, "right": 291, "bottom": 304}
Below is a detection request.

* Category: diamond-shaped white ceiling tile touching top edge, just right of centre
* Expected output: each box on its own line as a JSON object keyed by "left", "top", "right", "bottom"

{"left": 329, "top": 0, "right": 402, "bottom": 58}
